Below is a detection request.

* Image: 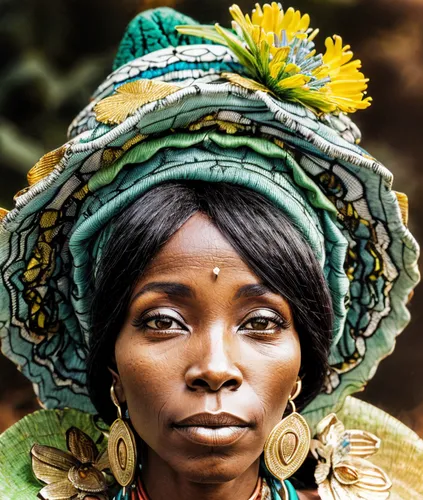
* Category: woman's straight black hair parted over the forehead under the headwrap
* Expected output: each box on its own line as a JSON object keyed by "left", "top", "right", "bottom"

{"left": 88, "top": 181, "right": 333, "bottom": 422}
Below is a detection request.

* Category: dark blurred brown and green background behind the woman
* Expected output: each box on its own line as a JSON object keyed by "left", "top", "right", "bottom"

{"left": 0, "top": 0, "right": 423, "bottom": 437}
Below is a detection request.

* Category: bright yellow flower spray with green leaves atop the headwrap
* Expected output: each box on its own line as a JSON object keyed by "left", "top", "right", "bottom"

{"left": 177, "top": 2, "right": 371, "bottom": 113}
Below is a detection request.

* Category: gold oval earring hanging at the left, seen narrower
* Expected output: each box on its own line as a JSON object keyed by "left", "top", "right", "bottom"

{"left": 107, "top": 384, "right": 137, "bottom": 488}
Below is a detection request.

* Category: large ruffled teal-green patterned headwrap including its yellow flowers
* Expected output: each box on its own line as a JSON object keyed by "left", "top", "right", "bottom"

{"left": 0, "top": 4, "right": 419, "bottom": 434}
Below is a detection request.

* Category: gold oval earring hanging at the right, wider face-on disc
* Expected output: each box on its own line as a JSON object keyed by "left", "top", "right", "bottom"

{"left": 264, "top": 379, "right": 311, "bottom": 481}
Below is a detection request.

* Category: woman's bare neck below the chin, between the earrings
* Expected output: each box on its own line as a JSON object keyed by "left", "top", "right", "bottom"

{"left": 141, "top": 452, "right": 259, "bottom": 500}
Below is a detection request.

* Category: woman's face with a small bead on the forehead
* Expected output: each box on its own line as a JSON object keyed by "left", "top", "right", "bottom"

{"left": 115, "top": 213, "right": 301, "bottom": 483}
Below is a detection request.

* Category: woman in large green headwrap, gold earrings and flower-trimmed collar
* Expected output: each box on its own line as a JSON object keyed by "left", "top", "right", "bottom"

{"left": 0, "top": 3, "right": 423, "bottom": 500}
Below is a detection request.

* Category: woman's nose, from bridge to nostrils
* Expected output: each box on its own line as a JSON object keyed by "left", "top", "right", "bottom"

{"left": 185, "top": 330, "right": 243, "bottom": 392}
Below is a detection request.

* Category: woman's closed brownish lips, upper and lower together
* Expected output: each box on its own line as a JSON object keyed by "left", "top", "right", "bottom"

{"left": 173, "top": 412, "right": 251, "bottom": 446}
